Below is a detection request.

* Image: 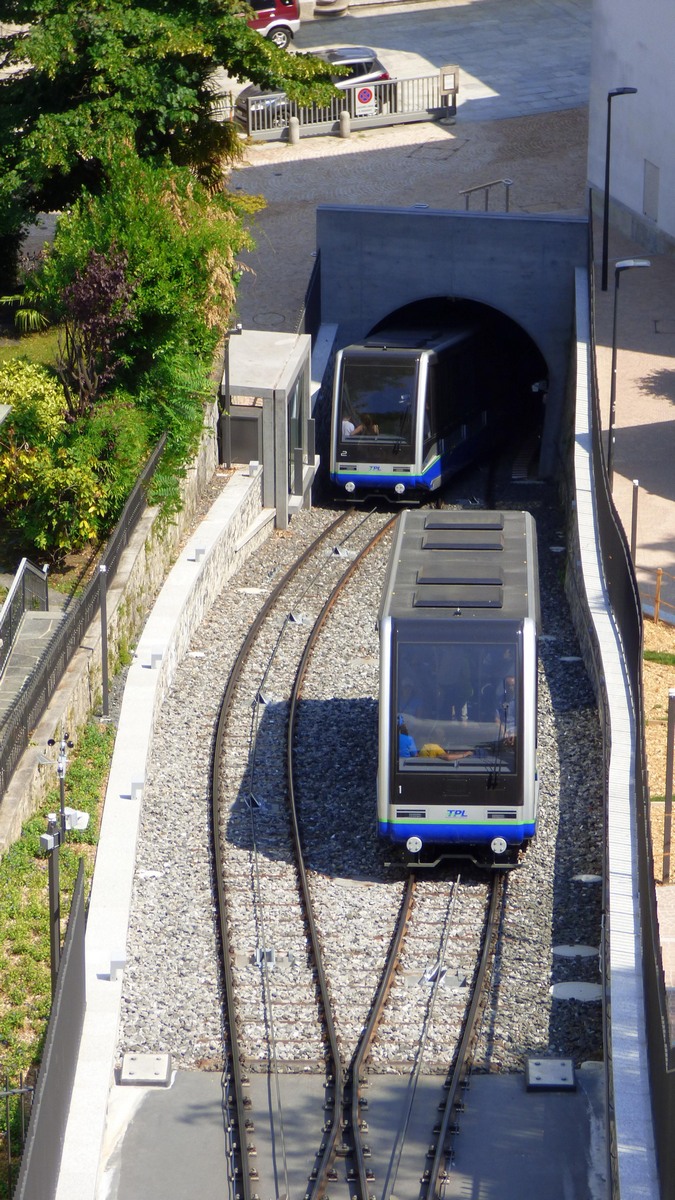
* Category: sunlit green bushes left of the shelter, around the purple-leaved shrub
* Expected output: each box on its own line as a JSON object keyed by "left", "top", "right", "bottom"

{"left": 11, "top": 156, "right": 241, "bottom": 552}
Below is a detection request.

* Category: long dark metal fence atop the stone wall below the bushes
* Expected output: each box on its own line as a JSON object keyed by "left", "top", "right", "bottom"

{"left": 0, "top": 434, "right": 166, "bottom": 796}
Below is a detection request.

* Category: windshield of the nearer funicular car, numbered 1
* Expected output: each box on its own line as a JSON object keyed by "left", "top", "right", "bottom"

{"left": 394, "top": 631, "right": 521, "bottom": 774}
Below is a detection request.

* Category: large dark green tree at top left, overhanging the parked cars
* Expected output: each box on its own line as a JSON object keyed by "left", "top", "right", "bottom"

{"left": 0, "top": 0, "right": 333, "bottom": 234}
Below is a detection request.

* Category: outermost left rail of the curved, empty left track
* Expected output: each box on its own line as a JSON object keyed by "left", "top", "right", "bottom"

{"left": 211, "top": 509, "right": 351, "bottom": 1200}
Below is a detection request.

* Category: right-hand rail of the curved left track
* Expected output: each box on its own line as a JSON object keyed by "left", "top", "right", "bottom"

{"left": 287, "top": 516, "right": 398, "bottom": 1200}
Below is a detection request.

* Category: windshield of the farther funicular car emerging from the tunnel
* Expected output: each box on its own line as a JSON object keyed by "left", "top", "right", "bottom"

{"left": 339, "top": 350, "right": 418, "bottom": 462}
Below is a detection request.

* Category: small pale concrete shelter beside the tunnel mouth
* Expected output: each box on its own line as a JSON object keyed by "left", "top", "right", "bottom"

{"left": 219, "top": 329, "right": 318, "bottom": 529}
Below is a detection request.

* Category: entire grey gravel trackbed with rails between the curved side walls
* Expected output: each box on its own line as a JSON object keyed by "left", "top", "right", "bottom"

{"left": 119, "top": 486, "right": 602, "bottom": 1200}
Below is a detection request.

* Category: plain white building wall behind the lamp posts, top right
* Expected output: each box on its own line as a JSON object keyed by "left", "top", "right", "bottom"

{"left": 589, "top": 0, "right": 675, "bottom": 251}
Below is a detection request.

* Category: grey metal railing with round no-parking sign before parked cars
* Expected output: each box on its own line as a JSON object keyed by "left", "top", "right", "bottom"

{"left": 234, "top": 74, "right": 456, "bottom": 142}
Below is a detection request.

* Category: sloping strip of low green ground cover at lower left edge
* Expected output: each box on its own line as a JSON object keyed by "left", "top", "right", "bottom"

{"left": 0, "top": 720, "right": 115, "bottom": 1196}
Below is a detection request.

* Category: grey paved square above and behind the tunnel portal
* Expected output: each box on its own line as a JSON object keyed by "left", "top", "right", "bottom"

{"left": 227, "top": 0, "right": 591, "bottom": 330}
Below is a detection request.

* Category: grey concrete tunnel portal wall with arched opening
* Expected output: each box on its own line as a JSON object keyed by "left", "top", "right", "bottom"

{"left": 317, "top": 205, "right": 587, "bottom": 475}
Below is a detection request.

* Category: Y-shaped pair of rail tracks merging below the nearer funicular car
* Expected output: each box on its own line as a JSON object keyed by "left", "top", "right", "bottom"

{"left": 213, "top": 514, "right": 504, "bottom": 1200}
